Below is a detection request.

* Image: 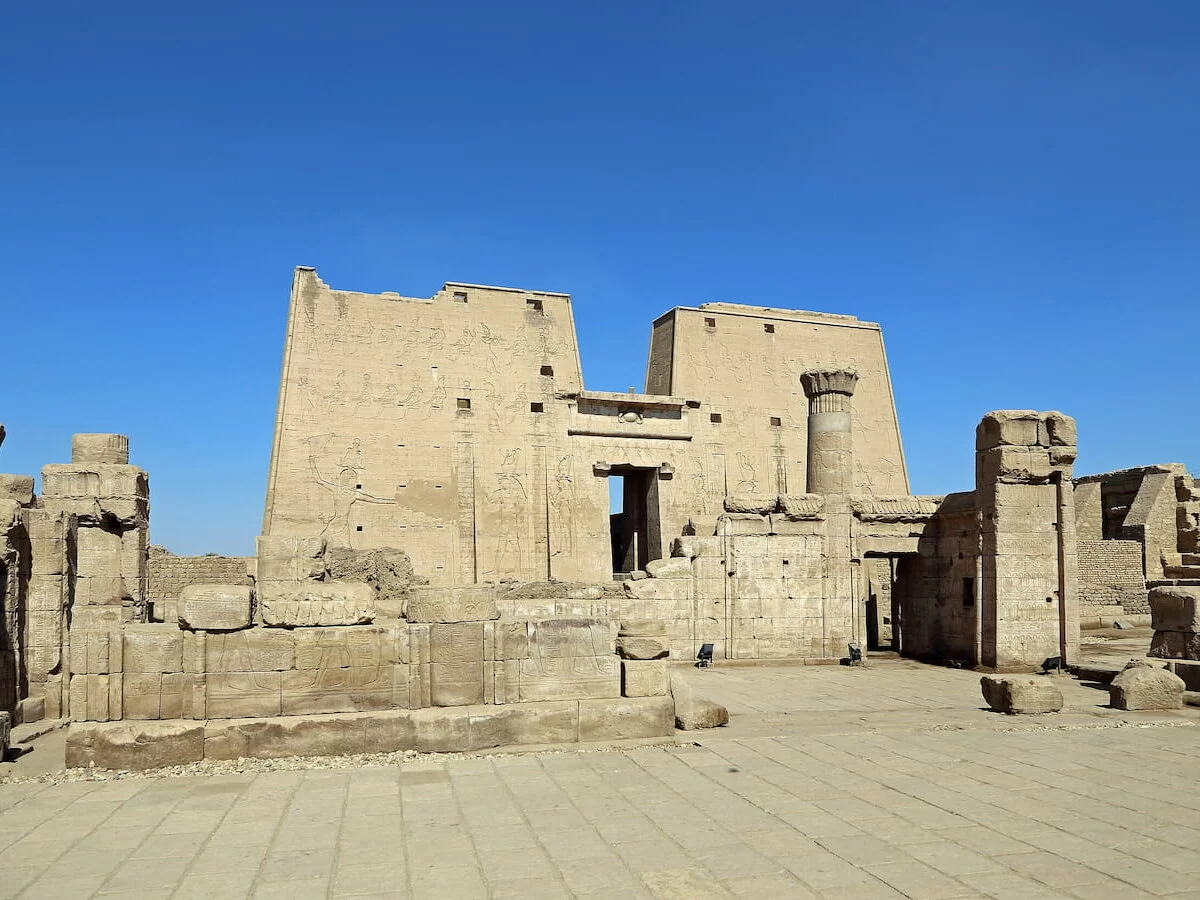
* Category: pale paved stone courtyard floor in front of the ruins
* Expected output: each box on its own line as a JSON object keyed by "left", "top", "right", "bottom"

{"left": 0, "top": 660, "right": 1200, "bottom": 900}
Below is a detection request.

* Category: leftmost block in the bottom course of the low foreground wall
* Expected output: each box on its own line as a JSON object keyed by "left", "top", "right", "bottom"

{"left": 66, "top": 721, "right": 204, "bottom": 770}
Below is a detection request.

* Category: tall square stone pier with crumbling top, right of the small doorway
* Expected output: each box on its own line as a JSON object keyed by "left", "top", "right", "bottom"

{"left": 976, "top": 409, "right": 1079, "bottom": 671}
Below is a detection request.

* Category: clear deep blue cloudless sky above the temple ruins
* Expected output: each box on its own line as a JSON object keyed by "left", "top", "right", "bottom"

{"left": 0, "top": 0, "right": 1200, "bottom": 553}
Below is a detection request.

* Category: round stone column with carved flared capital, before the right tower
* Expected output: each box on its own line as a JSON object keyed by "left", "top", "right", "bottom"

{"left": 800, "top": 368, "right": 858, "bottom": 494}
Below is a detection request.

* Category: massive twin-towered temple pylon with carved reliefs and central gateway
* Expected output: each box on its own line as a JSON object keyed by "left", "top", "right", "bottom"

{"left": 263, "top": 269, "right": 907, "bottom": 584}
